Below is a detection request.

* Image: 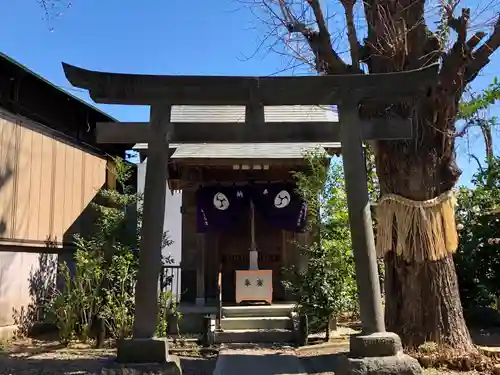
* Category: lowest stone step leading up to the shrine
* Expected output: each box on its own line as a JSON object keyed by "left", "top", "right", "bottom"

{"left": 214, "top": 329, "right": 294, "bottom": 344}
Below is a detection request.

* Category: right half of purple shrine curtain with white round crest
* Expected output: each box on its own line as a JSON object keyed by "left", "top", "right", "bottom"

{"left": 252, "top": 183, "right": 307, "bottom": 232}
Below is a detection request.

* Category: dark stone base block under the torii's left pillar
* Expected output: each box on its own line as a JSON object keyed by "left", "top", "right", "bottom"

{"left": 116, "top": 338, "right": 181, "bottom": 375}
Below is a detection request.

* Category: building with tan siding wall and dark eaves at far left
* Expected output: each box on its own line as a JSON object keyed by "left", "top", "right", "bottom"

{"left": 0, "top": 54, "right": 132, "bottom": 336}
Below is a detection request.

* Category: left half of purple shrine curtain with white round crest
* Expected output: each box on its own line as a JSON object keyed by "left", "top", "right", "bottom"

{"left": 196, "top": 186, "right": 250, "bottom": 233}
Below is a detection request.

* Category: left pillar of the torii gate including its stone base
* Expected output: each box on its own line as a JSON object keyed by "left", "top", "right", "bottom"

{"left": 117, "top": 104, "right": 177, "bottom": 373}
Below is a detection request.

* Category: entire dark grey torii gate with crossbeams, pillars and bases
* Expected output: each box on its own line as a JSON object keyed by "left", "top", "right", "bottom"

{"left": 63, "top": 63, "right": 438, "bottom": 374}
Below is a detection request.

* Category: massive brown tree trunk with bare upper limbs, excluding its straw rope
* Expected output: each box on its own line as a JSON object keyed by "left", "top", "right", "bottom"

{"left": 274, "top": 0, "right": 500, "bottom": 351}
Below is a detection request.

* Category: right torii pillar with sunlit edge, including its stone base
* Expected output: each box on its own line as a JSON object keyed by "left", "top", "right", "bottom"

{"left": 338, "top": 101, "right": 422, "bottom": 375}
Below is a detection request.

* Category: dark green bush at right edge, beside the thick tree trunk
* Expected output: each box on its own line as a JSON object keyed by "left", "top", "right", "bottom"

{"left": 455, "top": 157, "right": 500, "bottom": 308}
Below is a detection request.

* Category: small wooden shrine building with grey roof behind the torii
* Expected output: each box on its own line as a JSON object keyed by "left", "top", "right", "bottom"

{"left": 169, "top": 143, "right": 338, "bottom": 304}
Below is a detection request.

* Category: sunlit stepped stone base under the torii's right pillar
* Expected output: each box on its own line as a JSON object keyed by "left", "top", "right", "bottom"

{"left": 336, "top": 332, "right": 423, "bottom": 375}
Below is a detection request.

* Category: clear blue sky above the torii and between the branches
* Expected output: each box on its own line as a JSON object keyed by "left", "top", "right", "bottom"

{"left": 0, "top": 0, "right": 500, "bottom": 187}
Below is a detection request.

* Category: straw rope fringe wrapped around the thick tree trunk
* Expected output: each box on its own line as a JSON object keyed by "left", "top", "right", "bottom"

{"left": 377, "top": 191, "right": 458, "bottom": 262}
